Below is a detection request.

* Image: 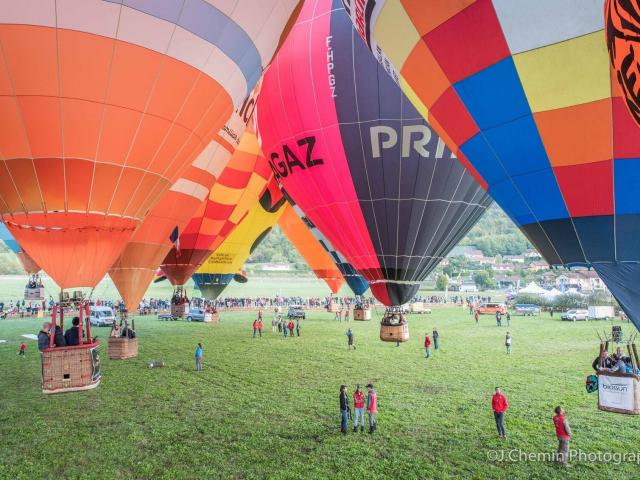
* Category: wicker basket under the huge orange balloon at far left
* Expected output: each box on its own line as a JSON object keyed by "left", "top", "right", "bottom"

{"left": 40, "top": 341, "right": 101, "bottom": 394}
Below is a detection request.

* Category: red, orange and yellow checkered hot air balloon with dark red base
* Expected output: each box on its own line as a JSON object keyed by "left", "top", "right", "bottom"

{"left": 162, "top": 127, "right": 273, "bottom": 285}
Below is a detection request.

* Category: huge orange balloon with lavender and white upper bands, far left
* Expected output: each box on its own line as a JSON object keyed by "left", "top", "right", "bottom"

{"left": 0, "top": 0, "right": 299, "bottom": 288}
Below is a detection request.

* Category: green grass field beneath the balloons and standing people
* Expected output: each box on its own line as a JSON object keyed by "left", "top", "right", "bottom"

{"left": 0, "top": 308, "right": 640, "bottom": 480}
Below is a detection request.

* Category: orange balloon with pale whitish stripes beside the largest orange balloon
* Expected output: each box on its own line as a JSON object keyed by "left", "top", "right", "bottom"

{"left": 109, "top": 88, "right": 260, "bottom": 311}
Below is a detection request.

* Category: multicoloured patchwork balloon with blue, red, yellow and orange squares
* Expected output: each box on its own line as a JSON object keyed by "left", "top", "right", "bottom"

{"left": 346, "top": 0, "right": 640, "bottom": 332}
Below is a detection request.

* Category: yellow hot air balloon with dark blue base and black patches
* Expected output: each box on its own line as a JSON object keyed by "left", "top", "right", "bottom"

{"left": 193, "top": 180, "right": 286, "bottom": 300}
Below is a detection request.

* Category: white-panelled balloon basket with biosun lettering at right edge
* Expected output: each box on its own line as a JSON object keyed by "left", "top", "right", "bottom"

{"left": 598, "top": 372, "right": 640, "bottom": 415}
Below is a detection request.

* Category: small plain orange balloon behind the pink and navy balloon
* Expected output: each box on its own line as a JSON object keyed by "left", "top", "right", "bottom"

{"left": 278, "top": 205, "right": 345, "bottom": 294}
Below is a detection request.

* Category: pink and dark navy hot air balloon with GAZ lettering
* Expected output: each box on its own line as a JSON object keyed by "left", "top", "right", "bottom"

{"left": 257, "top": 0, "right": 490, "bottom": 306}
